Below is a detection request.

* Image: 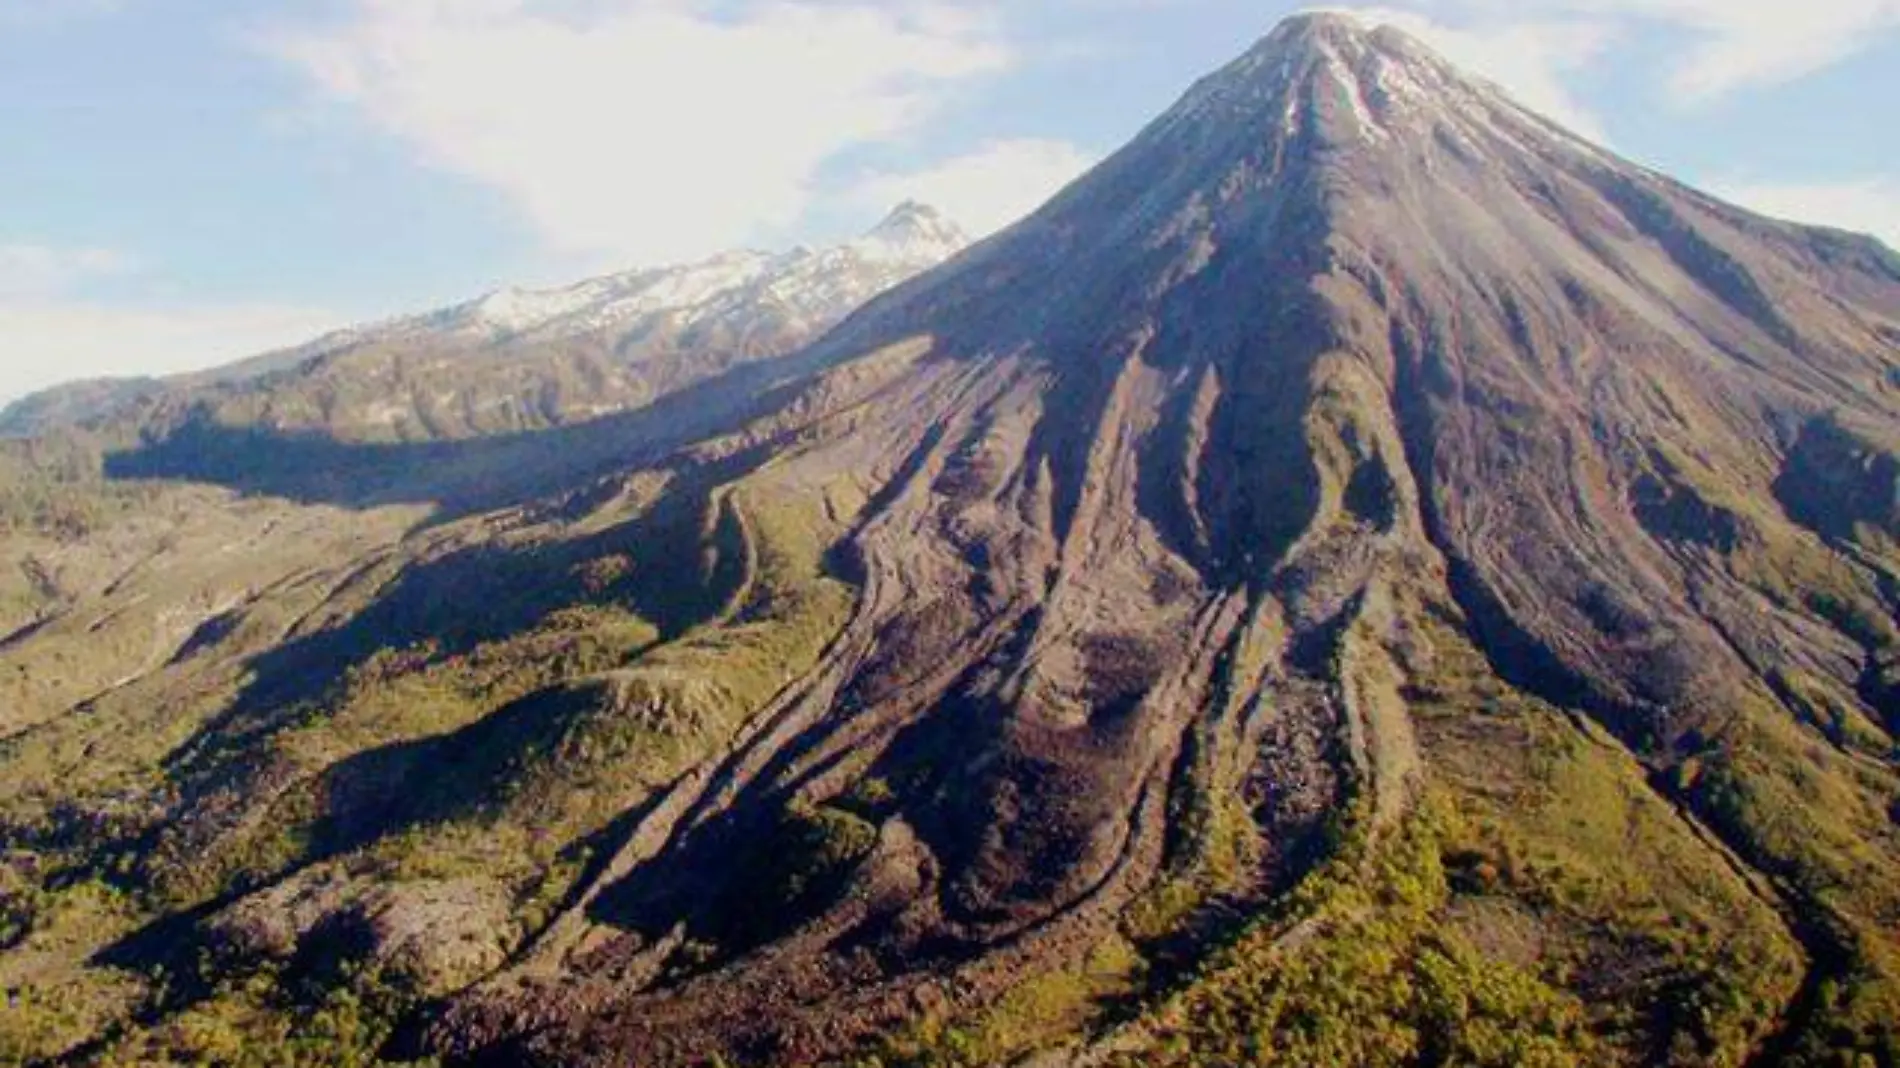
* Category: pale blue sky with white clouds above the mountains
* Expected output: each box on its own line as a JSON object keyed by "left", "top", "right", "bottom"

{"left": 0, "top": 0, "right": 1900, "bottom": 401}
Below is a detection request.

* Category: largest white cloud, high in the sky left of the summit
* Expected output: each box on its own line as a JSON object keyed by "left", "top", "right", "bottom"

{"left": 264, "top": 0, "right": 1009, "bottom": 262}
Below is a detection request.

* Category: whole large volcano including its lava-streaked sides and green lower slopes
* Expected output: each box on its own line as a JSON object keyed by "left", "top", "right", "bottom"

{"left": 0, "top": 15, "right": 1900, "bottom": 1068}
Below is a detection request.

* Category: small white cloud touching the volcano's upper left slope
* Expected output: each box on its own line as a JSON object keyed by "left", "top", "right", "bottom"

{"left": 847, "top": 139, "right": 1096, "bottom": 236}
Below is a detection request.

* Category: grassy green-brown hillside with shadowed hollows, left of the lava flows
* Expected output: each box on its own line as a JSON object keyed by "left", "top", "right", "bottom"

{"left": 0, "top": 459, "right": 855, "bottom": 1066}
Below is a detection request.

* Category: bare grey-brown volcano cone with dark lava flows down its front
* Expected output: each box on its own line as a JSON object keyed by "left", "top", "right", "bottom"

{"left": 408, "top": 15, "right": 1900, "bottom": 1064}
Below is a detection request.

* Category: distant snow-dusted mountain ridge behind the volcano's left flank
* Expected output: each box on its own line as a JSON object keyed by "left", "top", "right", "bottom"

{"left": 0, "top": 201, "right": 969, "bottom": 441}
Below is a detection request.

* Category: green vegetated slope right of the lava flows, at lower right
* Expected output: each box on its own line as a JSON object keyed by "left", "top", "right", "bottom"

{"left": 863, "top": 592, "right": 1824, "bottom": 1068}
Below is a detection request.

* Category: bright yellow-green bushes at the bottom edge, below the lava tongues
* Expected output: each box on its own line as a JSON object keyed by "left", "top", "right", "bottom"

{"left": 1121, "top": 806, "right": 1602, "bottom": 1068}
